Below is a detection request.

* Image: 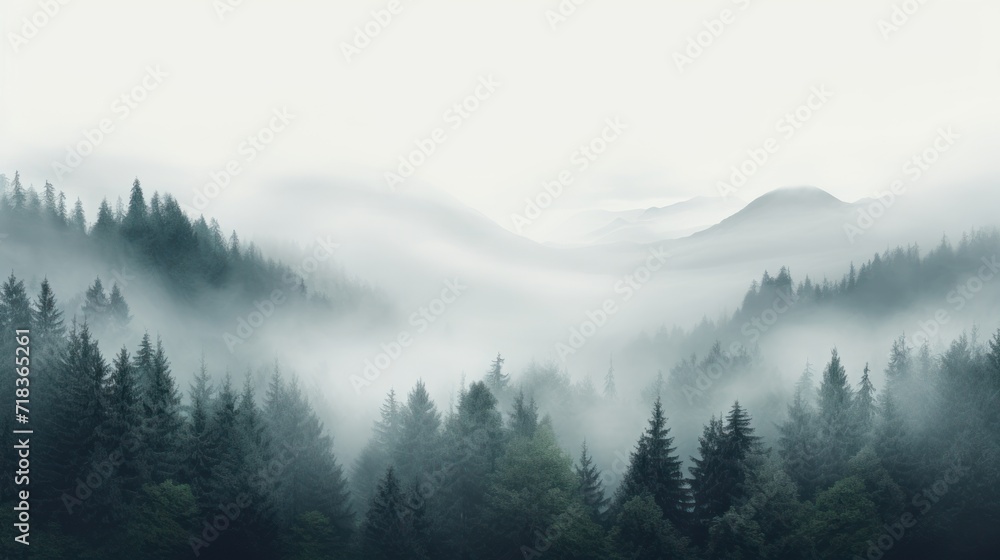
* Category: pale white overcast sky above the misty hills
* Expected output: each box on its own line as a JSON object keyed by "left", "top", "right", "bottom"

{"left": 0, "top": 0, "right": 1000, "bottom": 234}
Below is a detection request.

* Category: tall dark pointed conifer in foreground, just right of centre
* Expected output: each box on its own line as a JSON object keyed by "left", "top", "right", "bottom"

{"left": 615, "top": 398, "right": 690, "bottom": 527}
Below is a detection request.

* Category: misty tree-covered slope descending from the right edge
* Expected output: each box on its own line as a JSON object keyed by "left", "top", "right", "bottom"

{"left": 626, "top": 228, "right": 1000, "bottom": 406}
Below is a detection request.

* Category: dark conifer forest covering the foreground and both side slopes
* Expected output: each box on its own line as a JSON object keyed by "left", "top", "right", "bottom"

{"left": 0, "top": 176, "right": 1000, "bottom": 560}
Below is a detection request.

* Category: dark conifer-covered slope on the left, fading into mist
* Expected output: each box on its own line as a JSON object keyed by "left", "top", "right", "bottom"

{"left": 0, "top": 173, "right": 384, "bottom": 348}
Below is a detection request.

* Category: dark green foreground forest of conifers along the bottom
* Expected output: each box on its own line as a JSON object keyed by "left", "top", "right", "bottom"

{"left": 0, "top": 237, "right": 1000, "bottom": 560}
